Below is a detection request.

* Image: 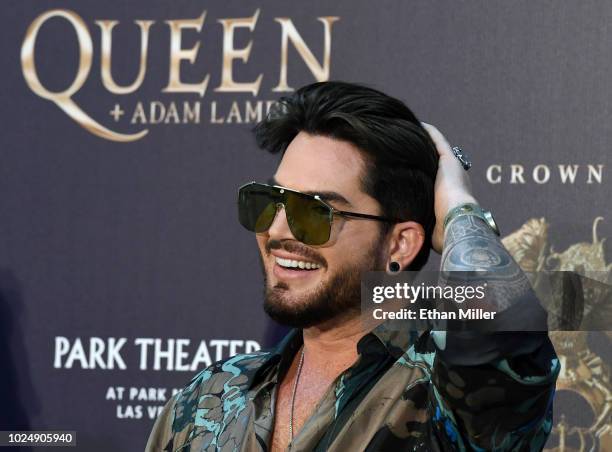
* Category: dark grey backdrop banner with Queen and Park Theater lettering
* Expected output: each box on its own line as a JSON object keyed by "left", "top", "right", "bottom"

{"left": 0, "top": 0, "right": 612, "bottom": 452}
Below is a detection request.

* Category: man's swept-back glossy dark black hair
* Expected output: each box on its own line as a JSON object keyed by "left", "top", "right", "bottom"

{"left": 254, "top": 81, "right": 438, "bottom": 270}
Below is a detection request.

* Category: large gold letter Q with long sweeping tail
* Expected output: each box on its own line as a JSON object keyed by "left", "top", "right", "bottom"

{"left": 21, "top": 9, "right": 148, "bottom": 142}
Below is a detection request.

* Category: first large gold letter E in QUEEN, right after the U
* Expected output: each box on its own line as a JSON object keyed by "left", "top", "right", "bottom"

{"left": 163, "top": 11, "right": 210, "bottom": 97}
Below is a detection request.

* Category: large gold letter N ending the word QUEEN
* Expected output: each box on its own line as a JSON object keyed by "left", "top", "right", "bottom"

{"left": 272, "top": 16, "right": 340, "bottom": 92}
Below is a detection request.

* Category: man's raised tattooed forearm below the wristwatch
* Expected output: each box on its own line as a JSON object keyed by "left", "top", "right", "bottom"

{"left": 441, "top": 215, "right": 532, "bottom": 311}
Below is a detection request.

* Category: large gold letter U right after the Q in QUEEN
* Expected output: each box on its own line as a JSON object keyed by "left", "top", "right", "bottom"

{"left": 96, "top": 20, "right": 154, "bottom": 94}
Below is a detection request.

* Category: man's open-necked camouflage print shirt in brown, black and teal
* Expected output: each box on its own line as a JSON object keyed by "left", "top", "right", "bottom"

{"left": 146, "top": 325, "right": 559, "bottom": 452}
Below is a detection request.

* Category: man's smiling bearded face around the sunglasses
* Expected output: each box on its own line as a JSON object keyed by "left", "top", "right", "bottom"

{"left": 257, "top": 132, "right": 385, "bottom": 328}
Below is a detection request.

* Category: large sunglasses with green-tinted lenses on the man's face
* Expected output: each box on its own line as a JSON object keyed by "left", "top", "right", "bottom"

{"left": 238, "top": 182, "right": 402, "bottom": 245}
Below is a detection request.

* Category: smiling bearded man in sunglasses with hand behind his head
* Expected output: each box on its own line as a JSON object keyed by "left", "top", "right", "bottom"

{"left": 147, "top": 82, "right": 559, "bottom": 451}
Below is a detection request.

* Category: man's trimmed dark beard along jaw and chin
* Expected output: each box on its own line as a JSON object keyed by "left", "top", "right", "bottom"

{"left": 262, "top": 234, "right": 384, "bottom": 328}
